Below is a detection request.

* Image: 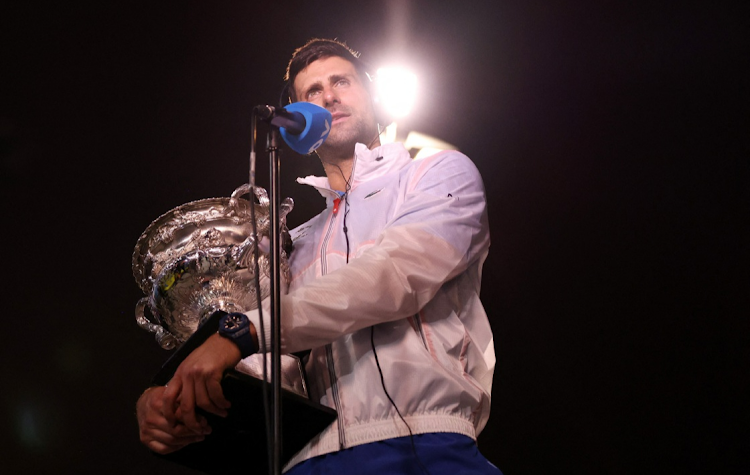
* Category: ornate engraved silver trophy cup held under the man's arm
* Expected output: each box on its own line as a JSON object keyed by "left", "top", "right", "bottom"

{"left": 132, "top": 184, "right": 306, "bottom": 396}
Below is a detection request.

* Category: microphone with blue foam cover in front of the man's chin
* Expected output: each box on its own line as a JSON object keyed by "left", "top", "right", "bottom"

{"left": 259, "top": 102, "right": 332, "bottom": 155}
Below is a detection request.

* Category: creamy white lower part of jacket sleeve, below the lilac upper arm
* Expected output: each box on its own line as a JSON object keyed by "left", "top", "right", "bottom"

{"left": 258, "top": 225, "right": 482, "bottom": 352}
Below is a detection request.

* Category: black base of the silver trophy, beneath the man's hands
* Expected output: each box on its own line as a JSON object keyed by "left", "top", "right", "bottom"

{"left": 153, "top": 313, "right": 336, "bottom": 475}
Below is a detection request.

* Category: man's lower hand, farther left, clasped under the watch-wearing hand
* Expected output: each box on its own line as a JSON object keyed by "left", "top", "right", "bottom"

{"left": 136, "top": 386, "right": 211, "bottom": 455}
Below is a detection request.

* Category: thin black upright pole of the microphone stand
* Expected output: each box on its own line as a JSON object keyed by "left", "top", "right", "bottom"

{"left": 266, "top": 125, "right": 282, "bottom": 475}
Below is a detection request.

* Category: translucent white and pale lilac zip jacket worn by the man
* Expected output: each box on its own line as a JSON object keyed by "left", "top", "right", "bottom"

{"left": 248, "top": 144, "right": 495, "bottom": 468}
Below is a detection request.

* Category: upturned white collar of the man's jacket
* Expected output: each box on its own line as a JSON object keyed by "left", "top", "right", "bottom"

{"left": 297, "top": 142, "right": 411, "bottom": 199}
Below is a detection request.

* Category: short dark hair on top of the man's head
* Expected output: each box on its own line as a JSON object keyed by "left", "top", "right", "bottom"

{"left": 282, "top": 38, "right": 370, "bottom": 102}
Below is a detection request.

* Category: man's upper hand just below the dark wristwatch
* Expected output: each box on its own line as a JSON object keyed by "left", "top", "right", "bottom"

{"left": 162, "top": 334, "right": 240, "bottom": 433}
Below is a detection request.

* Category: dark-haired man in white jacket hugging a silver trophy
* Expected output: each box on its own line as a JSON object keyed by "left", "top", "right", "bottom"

{"left": 137, "top": 40, "right": 500, "bottom": 475}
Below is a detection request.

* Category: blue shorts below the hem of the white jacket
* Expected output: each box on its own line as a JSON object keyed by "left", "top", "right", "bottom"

{"left": 286, "top": 433, "right": 502, "bottom": 475}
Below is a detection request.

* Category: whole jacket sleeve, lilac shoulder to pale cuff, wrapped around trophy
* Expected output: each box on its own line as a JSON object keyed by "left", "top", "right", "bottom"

{"left": 248, "top": 152, "right": 489, "bottom": 352}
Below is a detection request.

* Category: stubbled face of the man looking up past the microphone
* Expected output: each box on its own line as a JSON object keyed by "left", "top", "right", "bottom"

{"left": 294, "top": 56, "right": 378, "bottom": 154}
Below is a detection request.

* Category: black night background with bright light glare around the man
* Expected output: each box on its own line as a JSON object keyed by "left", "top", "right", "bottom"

{"left": 0, "top": 0, "right": 750, "bottom": 475}
